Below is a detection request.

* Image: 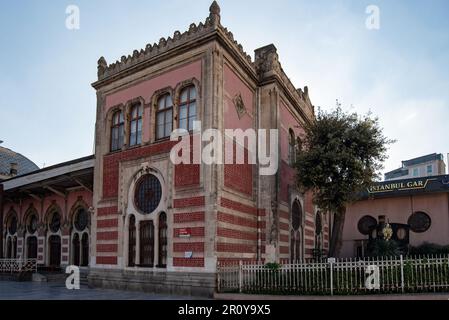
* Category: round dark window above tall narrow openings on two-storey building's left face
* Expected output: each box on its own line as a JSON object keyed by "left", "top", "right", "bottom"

{"left": 134, "top": 174, "right": 162, "bottom": 214}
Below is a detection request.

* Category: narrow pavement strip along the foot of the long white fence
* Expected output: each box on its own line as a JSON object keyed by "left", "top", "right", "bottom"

{"left": 214, "top": 293, "right": 449, "bottom": 301}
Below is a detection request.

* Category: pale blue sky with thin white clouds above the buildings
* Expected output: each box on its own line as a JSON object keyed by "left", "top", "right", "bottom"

{"left": 0, "top": 0, "right": 449, "bottom": 176}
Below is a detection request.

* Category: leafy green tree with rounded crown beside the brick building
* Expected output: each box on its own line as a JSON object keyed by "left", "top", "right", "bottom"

{"left": 295, "top": 105, "right": 394, "bottom": 256}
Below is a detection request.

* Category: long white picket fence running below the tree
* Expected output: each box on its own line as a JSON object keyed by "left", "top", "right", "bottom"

{"left": 217, "top": 255, "right": 449, "bottom": 295}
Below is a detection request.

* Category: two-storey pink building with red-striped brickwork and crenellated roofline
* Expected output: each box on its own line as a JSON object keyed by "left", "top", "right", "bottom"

{"left": 1, "top": 1, "right": 329, "bottom": 294}
